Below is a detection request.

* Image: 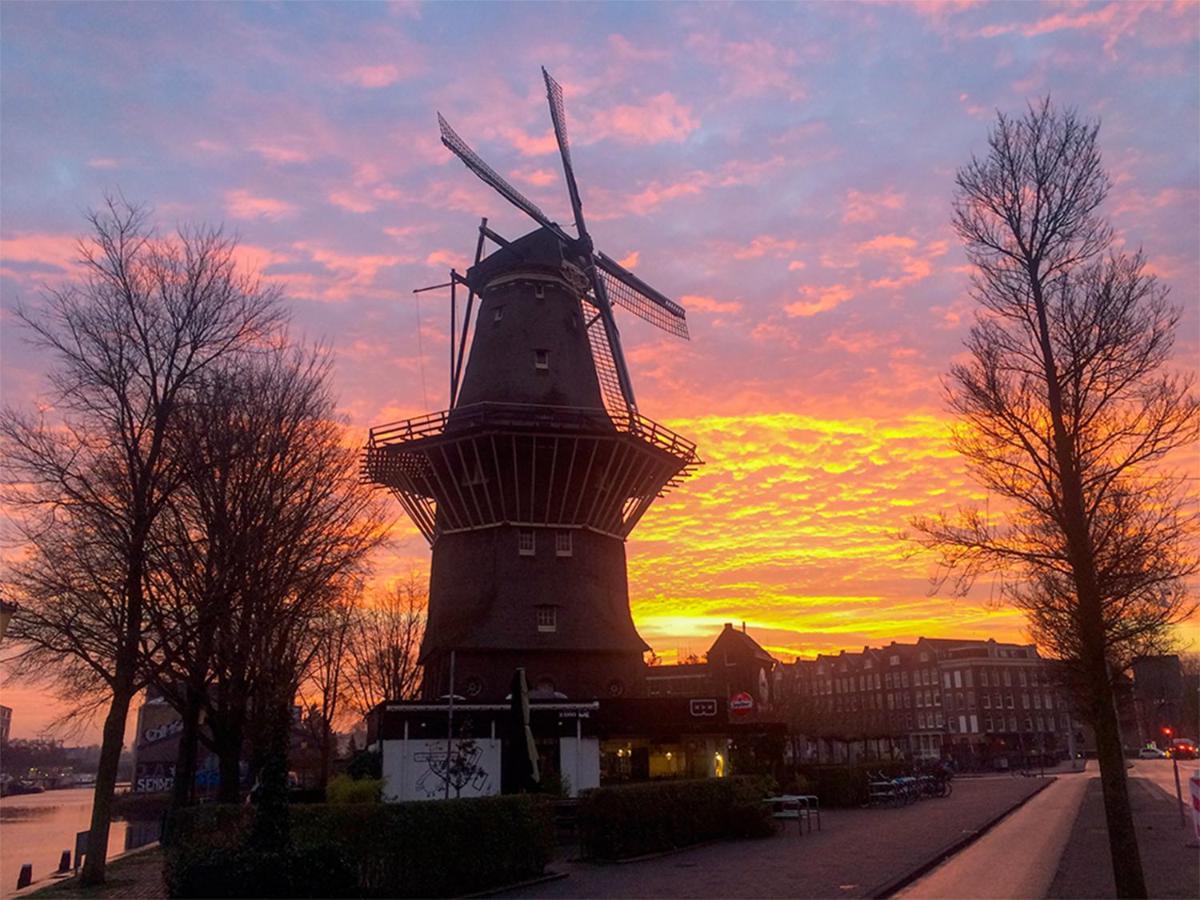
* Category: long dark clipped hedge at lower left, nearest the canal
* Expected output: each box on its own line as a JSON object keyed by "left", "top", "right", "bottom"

{"left": 164, "top": 797, "right": 554, "bottom": 898}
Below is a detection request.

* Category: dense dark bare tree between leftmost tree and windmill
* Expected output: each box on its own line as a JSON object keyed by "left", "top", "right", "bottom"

{"left": 151, "top": 347, "right": 383, "bottom": 825}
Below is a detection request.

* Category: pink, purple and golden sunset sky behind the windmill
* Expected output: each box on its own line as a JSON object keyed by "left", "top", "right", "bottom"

{"left": 0, "top": 0, "right": 1200, "bottom": 737}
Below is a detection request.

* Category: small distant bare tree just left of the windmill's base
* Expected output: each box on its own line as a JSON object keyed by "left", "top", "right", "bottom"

{"left": 346, "top": 574, "right": 427, "bottom": 715}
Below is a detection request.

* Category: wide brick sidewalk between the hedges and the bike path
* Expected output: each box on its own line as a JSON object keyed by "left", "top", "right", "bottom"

{"left": 501, "top": 776, "right": 1046, "bottom": 898}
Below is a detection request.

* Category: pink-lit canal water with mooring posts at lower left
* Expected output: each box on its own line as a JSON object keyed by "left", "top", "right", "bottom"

{"left": 0, "top": 787, "right": 157, "bottom": 896}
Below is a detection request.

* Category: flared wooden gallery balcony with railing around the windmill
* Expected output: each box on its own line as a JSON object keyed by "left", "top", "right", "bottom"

{"left": 362, "top": 403, "right": 702, "bottom": 544}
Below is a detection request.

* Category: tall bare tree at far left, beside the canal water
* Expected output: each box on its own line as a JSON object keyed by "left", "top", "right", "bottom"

{"left": 0, "top": 200, "right": 282, "bottom": 883}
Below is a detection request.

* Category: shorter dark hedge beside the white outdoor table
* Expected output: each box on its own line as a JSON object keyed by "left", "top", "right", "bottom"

{"left": 578, "top": 776, "right": 775, "bottom": 859}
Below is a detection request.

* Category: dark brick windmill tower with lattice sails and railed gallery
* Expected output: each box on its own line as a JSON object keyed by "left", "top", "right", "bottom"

{"left": 365, "top": 70, "right": 700, "bottom": 701}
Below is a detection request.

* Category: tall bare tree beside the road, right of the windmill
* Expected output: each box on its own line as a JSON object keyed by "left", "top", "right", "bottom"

{"left": 914, "top": 98, "right": 1200, "bottom": 896}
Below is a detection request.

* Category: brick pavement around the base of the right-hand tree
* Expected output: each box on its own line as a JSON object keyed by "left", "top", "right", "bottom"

{"left": 1049, "top": 778, "right": 1200, "bottom": 900}
